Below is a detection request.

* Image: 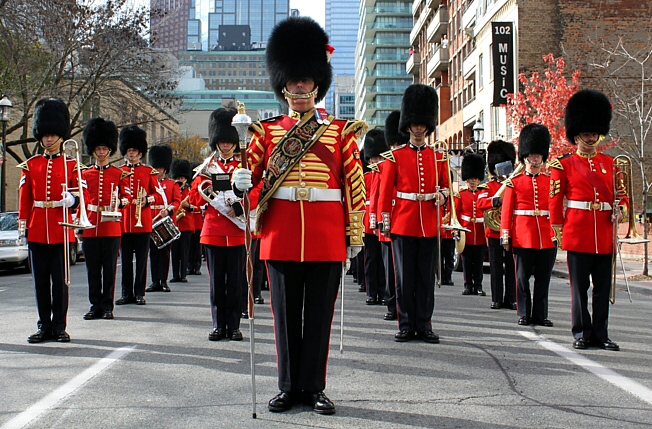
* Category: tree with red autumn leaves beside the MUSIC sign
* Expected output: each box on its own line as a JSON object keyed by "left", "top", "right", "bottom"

{"left": 507, "top": 54, "right": 580, "bottom": 159}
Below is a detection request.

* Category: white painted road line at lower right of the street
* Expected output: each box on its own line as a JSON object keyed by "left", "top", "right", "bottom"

{"left": 519, "top": 331, "right": 652, "bottom": 404}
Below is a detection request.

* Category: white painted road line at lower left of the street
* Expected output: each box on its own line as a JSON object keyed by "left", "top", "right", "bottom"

{"left": 0, "top": 346, "right": 136, "bottom": 429}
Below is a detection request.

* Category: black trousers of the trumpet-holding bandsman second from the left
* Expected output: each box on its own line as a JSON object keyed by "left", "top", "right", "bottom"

{"left": 82, "top": 237, "right": 120, "bottom": 313}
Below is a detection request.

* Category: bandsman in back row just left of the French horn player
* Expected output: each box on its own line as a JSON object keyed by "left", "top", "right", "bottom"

{"left": 455, "top": 153, "right": 487, "bottom": 296}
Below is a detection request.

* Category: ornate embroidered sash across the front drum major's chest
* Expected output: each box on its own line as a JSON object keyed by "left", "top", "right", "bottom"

{"left": 256, "top": 109, "right": 333, "bottom": 233}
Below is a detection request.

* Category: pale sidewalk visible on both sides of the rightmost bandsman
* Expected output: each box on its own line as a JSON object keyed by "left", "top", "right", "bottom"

{"left": 552, "top": 250, "right": 652, "bottom": 300}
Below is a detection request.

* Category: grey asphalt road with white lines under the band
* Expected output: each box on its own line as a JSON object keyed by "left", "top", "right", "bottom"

{"left": 0, "top": 263, "right": 652, "bottom": 429}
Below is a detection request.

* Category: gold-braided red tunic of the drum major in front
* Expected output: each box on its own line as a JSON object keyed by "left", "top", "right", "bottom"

{"left": 247, "top": 109, "right": 365, "bottom": 262}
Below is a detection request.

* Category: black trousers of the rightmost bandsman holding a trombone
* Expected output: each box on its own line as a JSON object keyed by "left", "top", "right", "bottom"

{"left": 566, "top": 251, "right": 611, "bottom": 342}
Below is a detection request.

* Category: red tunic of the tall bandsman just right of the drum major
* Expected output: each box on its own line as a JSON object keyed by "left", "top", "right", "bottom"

{"left": 379, "top": 143, "right": 449, "bottom": 237}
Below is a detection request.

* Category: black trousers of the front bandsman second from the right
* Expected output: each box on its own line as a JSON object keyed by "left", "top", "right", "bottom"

{"left": 513, "top": 247, "right": 557, "bottom": 320}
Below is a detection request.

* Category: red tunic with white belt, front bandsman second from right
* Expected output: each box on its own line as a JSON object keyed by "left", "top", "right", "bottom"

{"left": 500, "top": 173, "right": 556, "bottom": 249}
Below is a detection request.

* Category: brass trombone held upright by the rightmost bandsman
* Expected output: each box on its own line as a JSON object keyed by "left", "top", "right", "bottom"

{"left": 609, "top": 155, "right": 650, "bottom": 304}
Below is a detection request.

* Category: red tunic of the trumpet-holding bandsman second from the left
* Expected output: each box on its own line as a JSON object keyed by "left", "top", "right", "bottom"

{"left": 82, "top": 164, "right": 129, "bottom": 237}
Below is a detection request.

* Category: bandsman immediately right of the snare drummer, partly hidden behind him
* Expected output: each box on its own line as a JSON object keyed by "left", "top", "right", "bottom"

{"left": 170, "top": 159, "right": 195, "bottom": 283}
